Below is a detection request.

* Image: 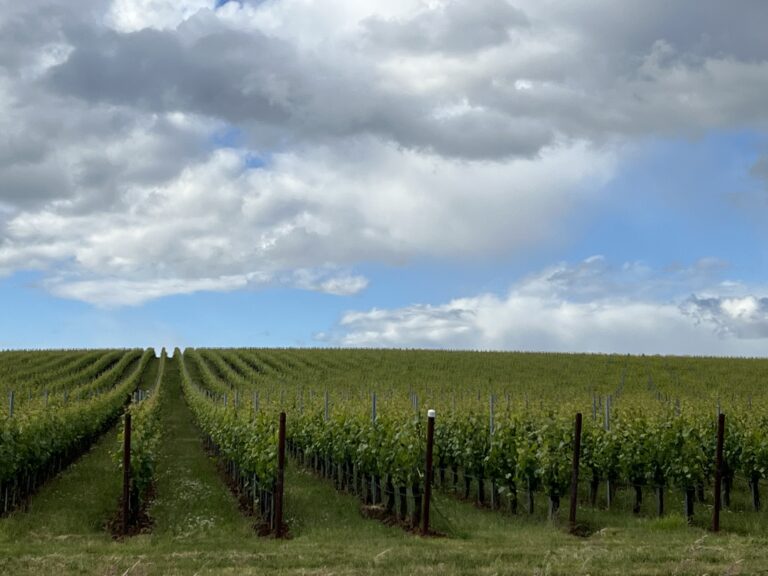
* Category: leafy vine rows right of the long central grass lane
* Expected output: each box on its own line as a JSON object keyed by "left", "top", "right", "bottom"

{"left": 177, "top": 350, "right": 768, "bottom": 526}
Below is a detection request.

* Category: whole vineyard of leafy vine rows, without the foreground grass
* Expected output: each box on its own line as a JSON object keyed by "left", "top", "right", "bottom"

{"left": 0, "top": 349, "right": 768, "bottom": 573}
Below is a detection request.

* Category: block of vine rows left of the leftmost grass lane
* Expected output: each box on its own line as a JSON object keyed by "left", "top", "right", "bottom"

{"left": 0, "top": 350, "right": 153, "bottom": 513}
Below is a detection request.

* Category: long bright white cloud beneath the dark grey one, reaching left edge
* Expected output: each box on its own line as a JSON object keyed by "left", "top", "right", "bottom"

{"left": 0, "top": 138, "right": 613, "bottom": 305}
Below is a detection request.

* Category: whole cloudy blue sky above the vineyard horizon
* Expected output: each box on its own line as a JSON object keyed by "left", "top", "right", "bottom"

{"left": 0, "top": 0, "right": 768, "bottom": 356}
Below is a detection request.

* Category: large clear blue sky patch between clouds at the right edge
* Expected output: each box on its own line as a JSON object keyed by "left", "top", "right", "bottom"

{"left": 566, "top": 132, "right": 766, "bottom": 274}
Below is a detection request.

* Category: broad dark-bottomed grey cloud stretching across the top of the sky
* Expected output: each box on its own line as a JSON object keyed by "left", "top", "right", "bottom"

{"left": 36, "top": 0, "right": 768, "bottom": 158}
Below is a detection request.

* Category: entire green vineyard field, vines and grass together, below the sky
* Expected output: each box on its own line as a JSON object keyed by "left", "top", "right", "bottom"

{"left": 0, "top": 350, "right": 768, "bottom": 574}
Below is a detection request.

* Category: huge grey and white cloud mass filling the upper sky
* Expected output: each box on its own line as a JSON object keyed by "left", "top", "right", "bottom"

{"left": 0, "top": 0, "right": 768, "bottom": 305}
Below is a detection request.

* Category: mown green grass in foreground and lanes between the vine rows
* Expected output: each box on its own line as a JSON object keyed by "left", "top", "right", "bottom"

{"left": 0, "top": 361, "right": 768, "bottom": 576}
